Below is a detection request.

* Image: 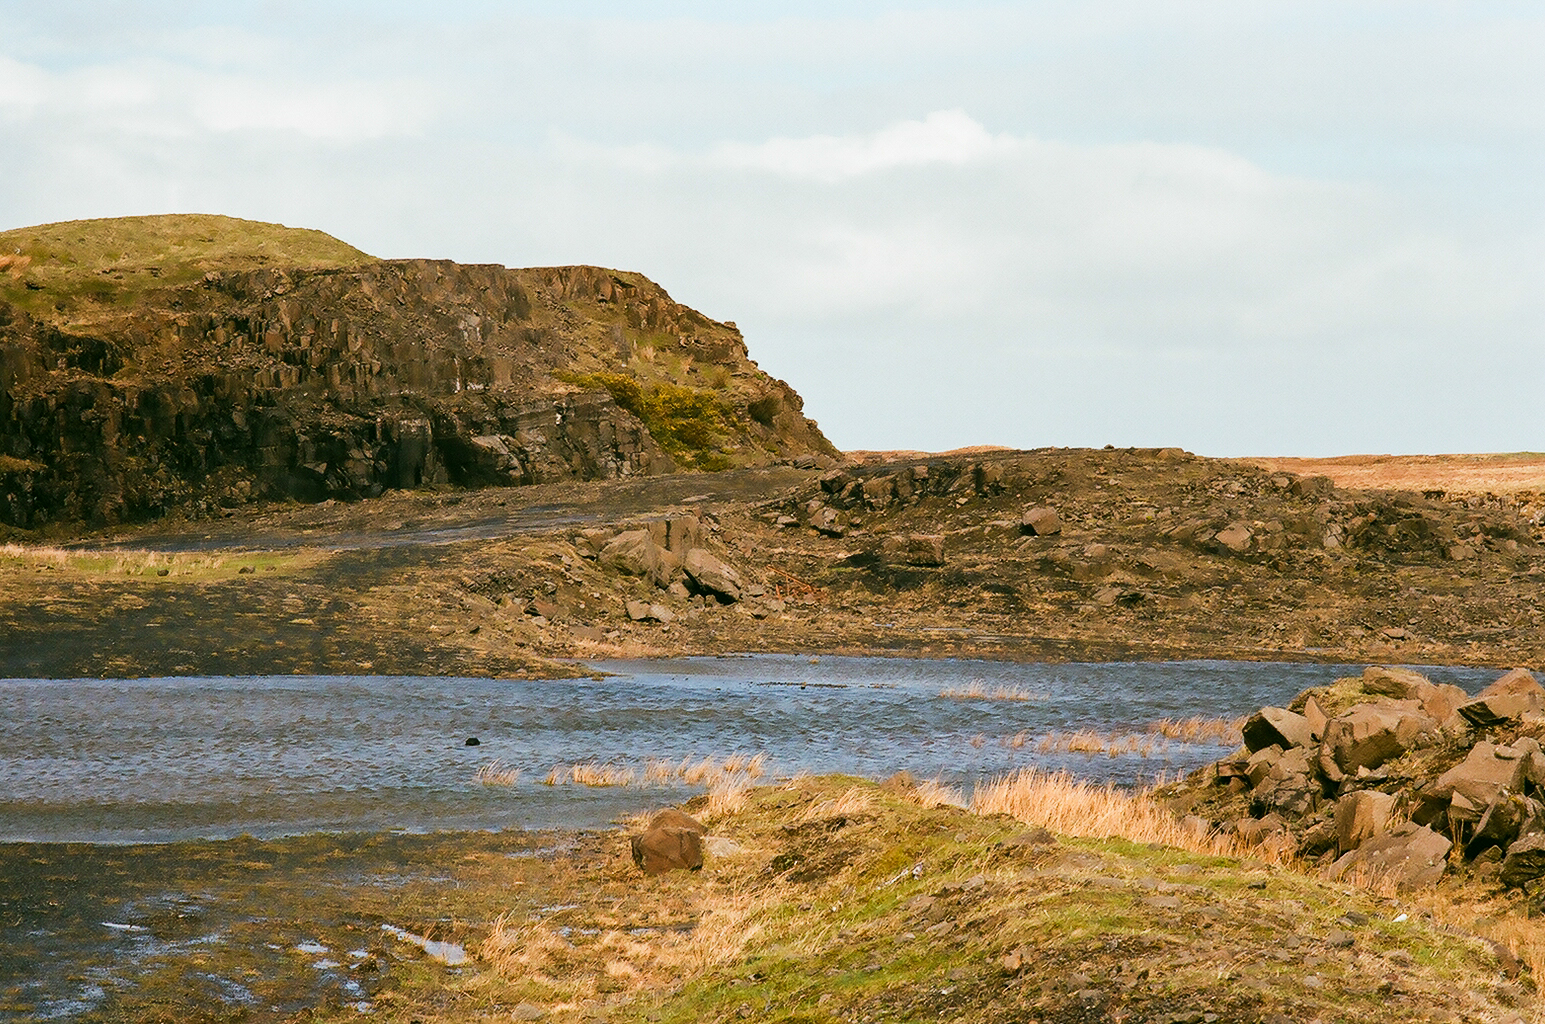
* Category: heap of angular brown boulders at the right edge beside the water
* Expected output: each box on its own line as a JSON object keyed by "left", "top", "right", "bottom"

{"left": 1171, "top": 666, "right": 1545, "bottom": 887}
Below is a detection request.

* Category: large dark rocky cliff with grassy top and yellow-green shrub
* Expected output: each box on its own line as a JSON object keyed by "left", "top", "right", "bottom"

{"left": 0, "top": 215, "right": 836, "bottom": 528}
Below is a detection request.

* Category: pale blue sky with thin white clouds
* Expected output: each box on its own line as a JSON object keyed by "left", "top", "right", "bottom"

{"left": 0, "top": 0, "right": 1545, "bottom": 456}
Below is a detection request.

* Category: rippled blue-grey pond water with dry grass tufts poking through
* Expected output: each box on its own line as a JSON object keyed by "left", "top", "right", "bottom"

{"left": 0, "top": 655, "right": 1496, "bottom": 842}
